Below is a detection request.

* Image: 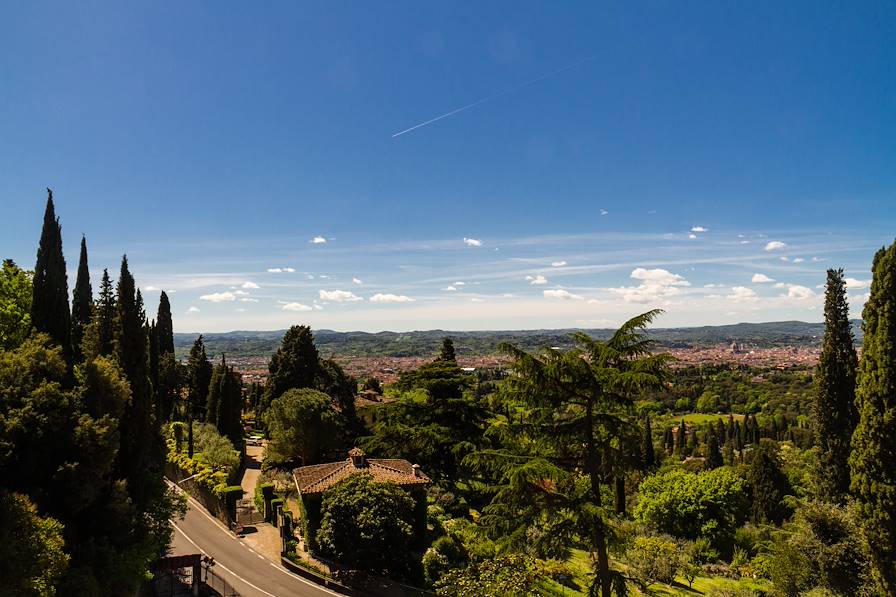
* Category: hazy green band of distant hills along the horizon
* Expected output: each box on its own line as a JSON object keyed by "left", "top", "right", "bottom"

{"left": 174, "top": 319, "right": 862, "bottom": 358}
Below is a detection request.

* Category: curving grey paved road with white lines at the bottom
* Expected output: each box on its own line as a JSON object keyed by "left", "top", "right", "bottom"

{"left": 172, "top": 488, "right": 339, "bottom": 597}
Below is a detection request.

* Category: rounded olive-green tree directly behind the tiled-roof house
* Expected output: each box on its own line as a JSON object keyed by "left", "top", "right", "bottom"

{"left": 264, "top": 388, "right": 340, "bottom": 465}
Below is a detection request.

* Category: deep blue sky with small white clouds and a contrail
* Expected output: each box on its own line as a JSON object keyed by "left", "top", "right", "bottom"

{"left": 0, "top": 2, "right": 896, "bottom": 331}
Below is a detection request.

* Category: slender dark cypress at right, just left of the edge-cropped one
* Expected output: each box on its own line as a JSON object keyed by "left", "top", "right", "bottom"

{"left": 813, "top": 269, "right": 858, "bottom": 502}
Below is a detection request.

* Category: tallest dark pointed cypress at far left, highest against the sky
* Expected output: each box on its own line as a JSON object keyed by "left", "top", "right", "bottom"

{"left": 31, "top": 189, "right": 72, "bottom": 363}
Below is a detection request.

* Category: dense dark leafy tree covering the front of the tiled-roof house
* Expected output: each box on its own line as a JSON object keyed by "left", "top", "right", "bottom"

{"left": 317, "top": 474, "right": 414, "bottom": 573}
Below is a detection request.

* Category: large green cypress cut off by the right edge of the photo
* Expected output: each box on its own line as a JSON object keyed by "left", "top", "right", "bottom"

{"left": 849, "top": 243, "right": 896, "bottom": 595}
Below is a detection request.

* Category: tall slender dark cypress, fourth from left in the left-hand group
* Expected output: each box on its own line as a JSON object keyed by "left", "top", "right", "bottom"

{"left": 115, "top": 256, "right": 161, "bottom": 508}
